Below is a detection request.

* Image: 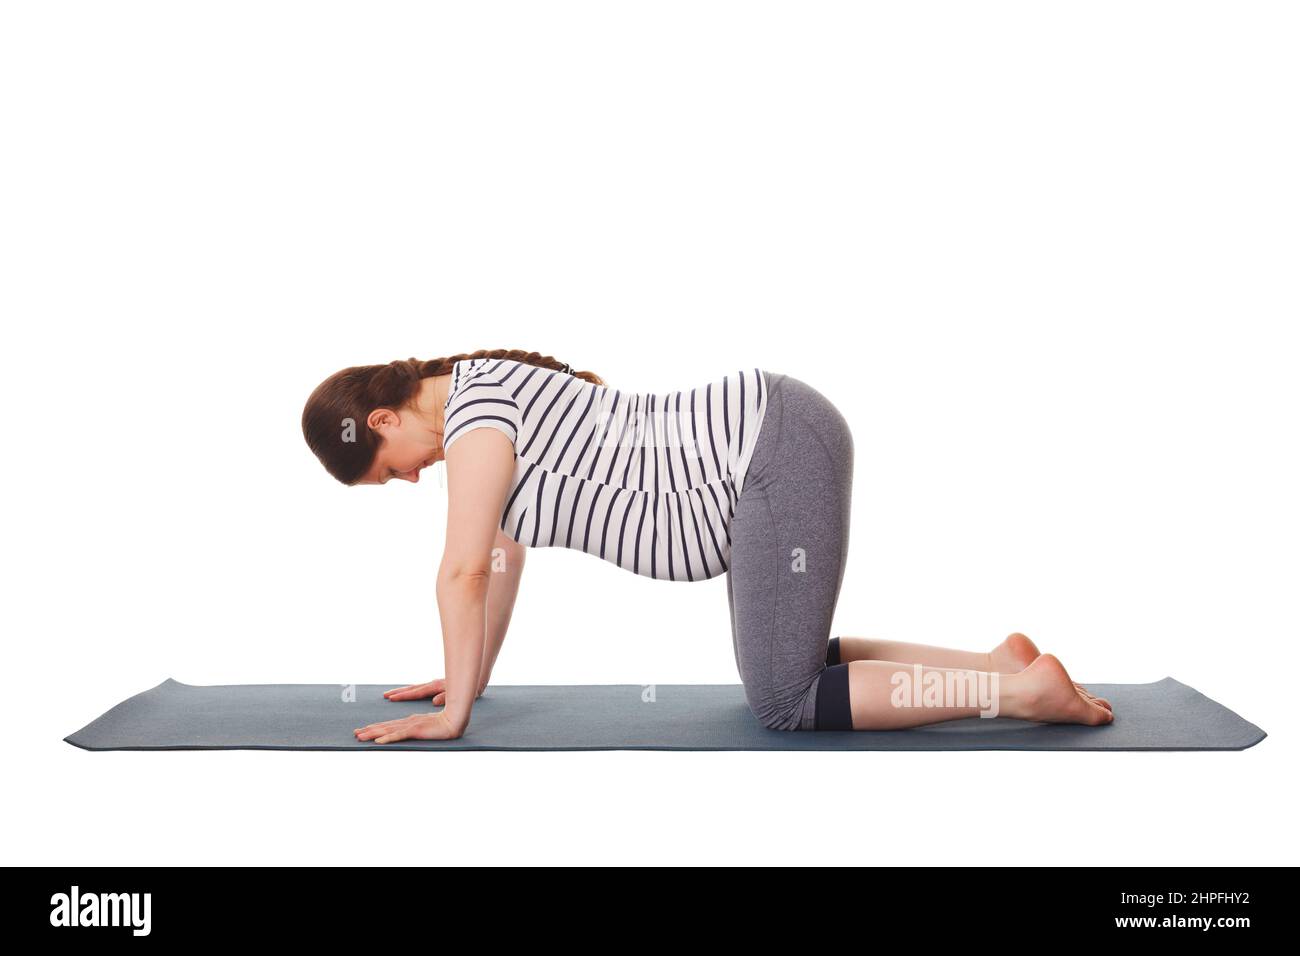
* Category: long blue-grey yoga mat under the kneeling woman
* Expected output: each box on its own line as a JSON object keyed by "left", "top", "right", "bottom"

{"left": 64, "top": 678, "right": 1266, "bottom": 750}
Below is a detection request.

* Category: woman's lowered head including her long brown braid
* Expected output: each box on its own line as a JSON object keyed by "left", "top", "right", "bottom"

{"left": 303, "top": 349, "right": 605, "bottom": 485}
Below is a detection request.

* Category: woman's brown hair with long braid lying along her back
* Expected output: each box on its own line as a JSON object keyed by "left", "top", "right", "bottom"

{"left": 303, "top": 349, "right": 605, "bottom": 485}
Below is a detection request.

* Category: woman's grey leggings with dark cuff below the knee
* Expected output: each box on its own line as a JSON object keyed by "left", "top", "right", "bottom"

{"left": 727, "top": 372, "right": 853, "bottom": 730}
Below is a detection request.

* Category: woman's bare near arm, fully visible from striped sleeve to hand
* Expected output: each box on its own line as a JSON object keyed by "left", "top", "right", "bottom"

{"left": 356, "top": 428, "right": 515, "bottom": 744}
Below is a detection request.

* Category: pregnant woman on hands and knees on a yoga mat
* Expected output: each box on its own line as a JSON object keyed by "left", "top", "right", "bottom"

{"left": 303, "top": 349, "right": 1113, "bottom": 744}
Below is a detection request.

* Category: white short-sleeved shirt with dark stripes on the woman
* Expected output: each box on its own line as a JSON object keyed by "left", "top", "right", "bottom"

{"left": 443, "top": 359, "right": 767, "bottom": 581}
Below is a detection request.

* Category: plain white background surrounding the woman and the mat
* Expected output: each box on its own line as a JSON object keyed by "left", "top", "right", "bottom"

{"left": 0, "top": 0, "right": 1300, "bottom": 865}
